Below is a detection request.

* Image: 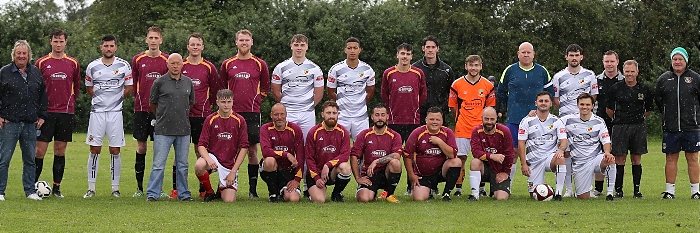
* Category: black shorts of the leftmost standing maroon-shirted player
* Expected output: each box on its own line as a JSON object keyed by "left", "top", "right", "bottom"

{"left": 36, "top": 112, "right": 74, "bottom": 142}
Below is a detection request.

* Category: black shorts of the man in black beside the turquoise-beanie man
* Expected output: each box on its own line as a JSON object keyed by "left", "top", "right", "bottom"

{"left": 610, "top": 124, "right": 649, "bottom": 156}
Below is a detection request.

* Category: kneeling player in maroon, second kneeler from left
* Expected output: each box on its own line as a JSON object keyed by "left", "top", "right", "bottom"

{"left": 260, "top": 103, "right": 304, "bottom": 202}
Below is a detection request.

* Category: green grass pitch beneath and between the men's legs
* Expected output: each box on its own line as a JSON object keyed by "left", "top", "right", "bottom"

{"left": 0, "top": 134, "right": 700, "bottom": 232}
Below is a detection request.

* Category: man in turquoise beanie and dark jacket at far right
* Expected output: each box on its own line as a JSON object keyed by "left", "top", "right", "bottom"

{"left": 654, "top": 47, "right": 700, "bottom": 199}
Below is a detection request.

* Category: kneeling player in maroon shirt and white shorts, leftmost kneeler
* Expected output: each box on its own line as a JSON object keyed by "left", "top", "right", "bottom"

{"left": 193, "top": 89, "right": 249, "bottom": 202}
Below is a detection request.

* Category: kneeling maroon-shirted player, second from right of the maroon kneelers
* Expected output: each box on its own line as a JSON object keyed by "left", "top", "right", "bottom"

{"left": 404, "top": 107, "right": 462, "bottom": 201}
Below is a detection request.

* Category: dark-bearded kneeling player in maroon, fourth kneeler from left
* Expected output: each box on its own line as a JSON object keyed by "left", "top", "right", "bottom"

{"left": 350, "top": 103, "right": 403, "bottom": 203}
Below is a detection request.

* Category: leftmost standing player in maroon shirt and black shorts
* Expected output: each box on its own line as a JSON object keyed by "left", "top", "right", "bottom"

{"left": 34, "top": 29, "right": 80, "bottom": 198}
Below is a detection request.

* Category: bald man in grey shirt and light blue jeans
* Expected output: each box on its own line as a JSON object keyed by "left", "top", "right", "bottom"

{"left": 146, "top": 53, "right": 194, "bottom": 201}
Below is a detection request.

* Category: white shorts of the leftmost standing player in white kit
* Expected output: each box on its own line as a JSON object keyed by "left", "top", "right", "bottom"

{"left": 85, "top": 111, "right": 126, "bottom": 147}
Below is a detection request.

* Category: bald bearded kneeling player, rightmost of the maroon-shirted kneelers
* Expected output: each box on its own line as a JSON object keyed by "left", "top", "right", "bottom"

{"left": 468, "top": 107, "right": 515, "bottom": 201}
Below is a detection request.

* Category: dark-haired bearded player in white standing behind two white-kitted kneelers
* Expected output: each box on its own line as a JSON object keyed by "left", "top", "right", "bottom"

{"left": 552, "top": 44, "right": 603, "bottom": 197}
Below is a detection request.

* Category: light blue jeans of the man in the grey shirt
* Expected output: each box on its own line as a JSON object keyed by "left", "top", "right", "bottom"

{"left": 146, "top": 135, "right": 192, "bottom": 200}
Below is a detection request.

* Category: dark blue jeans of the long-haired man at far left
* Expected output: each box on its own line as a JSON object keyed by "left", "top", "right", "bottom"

{"left": 0, "top": 122, "right": 36, "bottom": 196}
